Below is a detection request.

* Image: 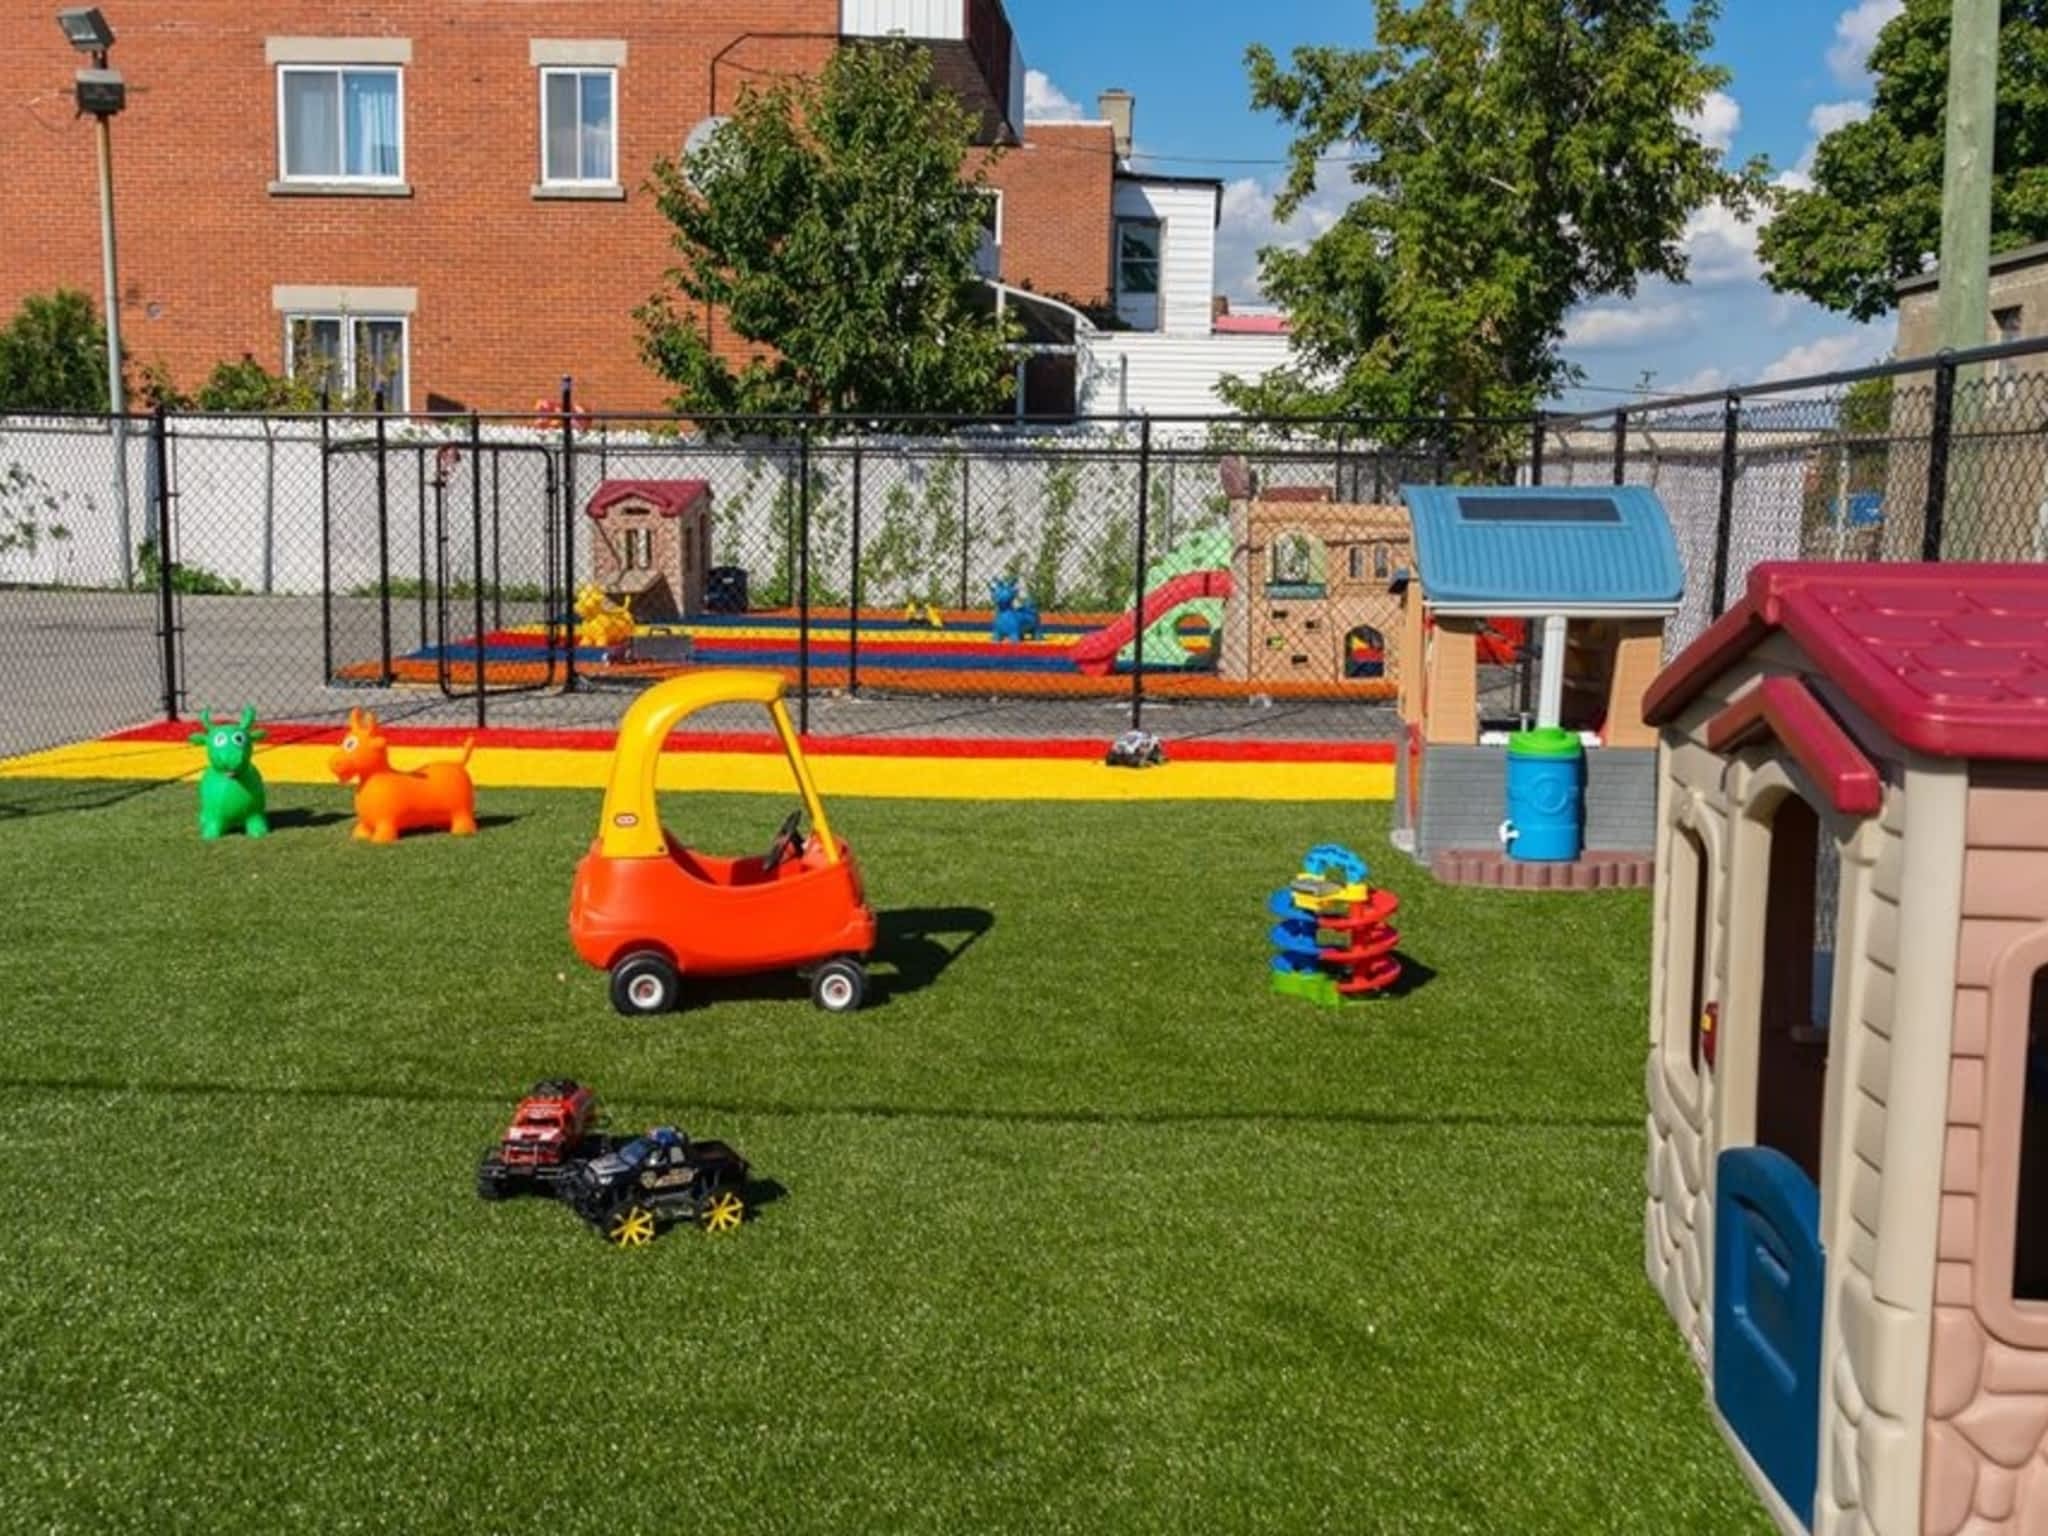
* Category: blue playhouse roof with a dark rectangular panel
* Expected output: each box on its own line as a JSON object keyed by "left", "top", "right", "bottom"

{"left": 1401, "top": 485, "right": 1686, "bottom": 610}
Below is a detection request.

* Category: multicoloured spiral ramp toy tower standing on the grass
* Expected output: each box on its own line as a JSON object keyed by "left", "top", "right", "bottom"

{"left": 1266, "top": 842, "right": 1401, "bottom": 1008}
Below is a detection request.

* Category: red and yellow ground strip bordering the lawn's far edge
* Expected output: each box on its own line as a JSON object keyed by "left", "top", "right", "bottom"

{"left": 0, "top": 721, "right": 1395, "bottom": 803}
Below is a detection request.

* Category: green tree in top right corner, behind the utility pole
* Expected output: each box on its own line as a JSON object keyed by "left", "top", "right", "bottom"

{"left": 1757, "top": 0, "right": 2048, "bottom": 319}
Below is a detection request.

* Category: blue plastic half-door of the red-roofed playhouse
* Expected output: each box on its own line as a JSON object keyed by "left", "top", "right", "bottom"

{"left": 1714, "top": 1147, "right": 1827, "bottom": 1530}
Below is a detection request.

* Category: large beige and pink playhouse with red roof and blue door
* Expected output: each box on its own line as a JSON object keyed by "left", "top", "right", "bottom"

{"left": 1645, "top": 565, "right": 2048, "bottom": 1536}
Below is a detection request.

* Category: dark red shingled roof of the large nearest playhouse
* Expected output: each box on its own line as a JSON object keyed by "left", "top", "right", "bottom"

{"left": 1642, "top": 561, "right": 2048, "bottom": 762}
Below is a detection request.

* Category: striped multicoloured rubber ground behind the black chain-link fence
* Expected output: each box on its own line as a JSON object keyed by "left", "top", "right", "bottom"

{"left": 338, "top": 604, "right": 1393, "bottom": 700}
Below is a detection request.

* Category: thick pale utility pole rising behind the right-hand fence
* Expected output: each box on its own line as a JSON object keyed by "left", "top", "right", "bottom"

{"left": 1935, "top": 0, "right": 1999, "bottom": 559}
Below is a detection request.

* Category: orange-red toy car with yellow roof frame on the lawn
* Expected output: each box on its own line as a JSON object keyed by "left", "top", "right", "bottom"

{"left": 569, "top": 672, "right": 874, "bottom": 1014}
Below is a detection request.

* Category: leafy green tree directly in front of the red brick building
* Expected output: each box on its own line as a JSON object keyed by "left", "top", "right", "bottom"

{"left": 635, "top": 43, "right": 1010, "bottom": 428}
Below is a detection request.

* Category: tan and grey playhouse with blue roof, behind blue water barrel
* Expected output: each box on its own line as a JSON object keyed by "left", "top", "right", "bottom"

{"left": 1393, "top": 485, "right": 1686, "bottom": 887}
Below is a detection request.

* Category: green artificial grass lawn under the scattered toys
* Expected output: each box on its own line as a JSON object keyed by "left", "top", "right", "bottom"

{"left": 0, "top": 782, "right": 1767, "bottom": 1536}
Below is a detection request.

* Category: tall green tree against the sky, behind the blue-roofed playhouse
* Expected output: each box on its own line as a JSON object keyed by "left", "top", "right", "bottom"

{"left": 1225, "top": 0, "right": 1763, "bottom": 442}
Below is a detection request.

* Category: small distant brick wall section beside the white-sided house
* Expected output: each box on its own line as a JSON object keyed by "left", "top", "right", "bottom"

{"left": 989, "top": 123, "right": 1116, "bottom": 305}
